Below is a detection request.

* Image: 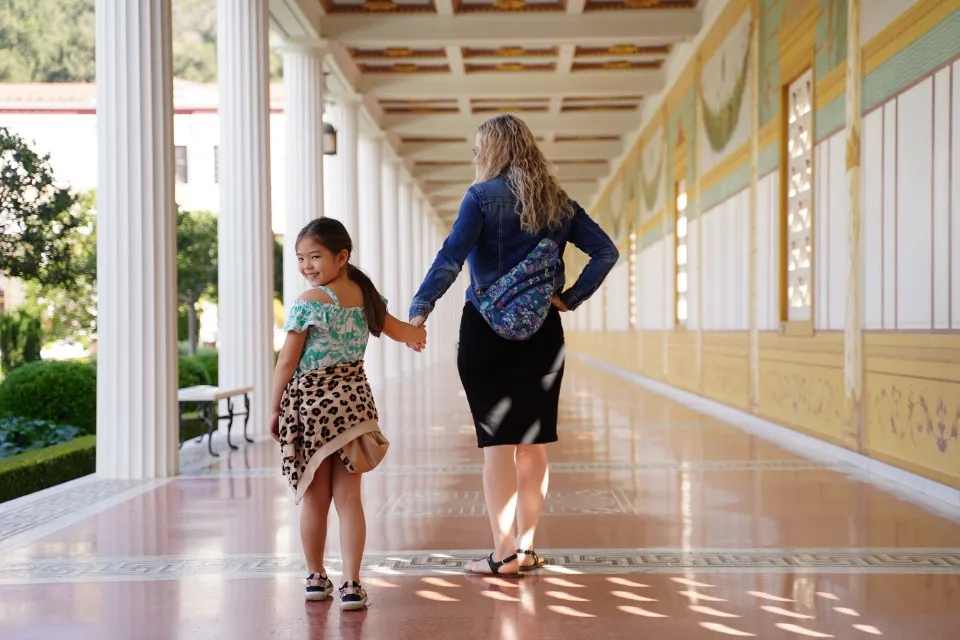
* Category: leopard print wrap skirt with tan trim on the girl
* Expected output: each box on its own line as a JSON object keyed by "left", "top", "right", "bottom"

{"left": 280, "top": 361, "right": 390, "bottom": 502}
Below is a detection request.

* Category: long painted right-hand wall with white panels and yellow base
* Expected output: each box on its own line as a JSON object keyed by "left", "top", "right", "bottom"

{"left": 569, "top": 0, "right": 960, "bottom": 488}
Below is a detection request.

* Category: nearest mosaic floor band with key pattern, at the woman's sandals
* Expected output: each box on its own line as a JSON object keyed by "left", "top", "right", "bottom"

{"left": 0, "top": 548, "right": 960, "bottom": 585}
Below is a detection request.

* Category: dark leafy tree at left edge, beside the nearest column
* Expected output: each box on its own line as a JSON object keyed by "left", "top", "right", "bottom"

{"left": 0, "top": 127, "right": 81, "bottom": 285}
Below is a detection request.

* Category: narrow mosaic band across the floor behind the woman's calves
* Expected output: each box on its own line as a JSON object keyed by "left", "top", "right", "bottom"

{"left": 179, "top": 460, "right": 850, "bottom": 479}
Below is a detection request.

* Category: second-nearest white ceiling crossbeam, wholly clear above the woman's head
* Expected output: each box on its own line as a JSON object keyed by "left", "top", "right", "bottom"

{"left": 356, "top": 69, "right": 666, "bottom": 100}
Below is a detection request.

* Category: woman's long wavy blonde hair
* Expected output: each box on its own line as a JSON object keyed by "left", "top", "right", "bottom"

{"left": 474, "top": 114, "right": 573, "bottom": 233}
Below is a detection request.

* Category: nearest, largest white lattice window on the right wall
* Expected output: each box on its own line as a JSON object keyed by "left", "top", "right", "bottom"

{"left": 782, "top": 70, "right": 813, "bottom": 322}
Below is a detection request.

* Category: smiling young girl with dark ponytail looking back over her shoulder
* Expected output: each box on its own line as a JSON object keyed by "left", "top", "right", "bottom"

{"left": 270, "top": 218, "right": 427, "bottom": 610}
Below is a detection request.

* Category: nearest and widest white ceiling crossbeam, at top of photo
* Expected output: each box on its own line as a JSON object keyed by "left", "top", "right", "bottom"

{"left": 320, "top": 9, "right": 701, "bottom": 47}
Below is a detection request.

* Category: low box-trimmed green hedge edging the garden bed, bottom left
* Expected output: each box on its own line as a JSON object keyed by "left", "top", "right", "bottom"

{"left": 0, "top": 436, "right": 97, "bottom": 502}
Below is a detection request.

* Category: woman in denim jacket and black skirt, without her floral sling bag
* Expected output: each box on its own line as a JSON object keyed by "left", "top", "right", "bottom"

{"left": 410, "top": 115, "right": 619, "bottom": 576}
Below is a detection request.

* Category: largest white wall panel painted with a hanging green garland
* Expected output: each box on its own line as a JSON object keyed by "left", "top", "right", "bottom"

{"left": 697, "top": 11, "right": 752, "bottom": 174}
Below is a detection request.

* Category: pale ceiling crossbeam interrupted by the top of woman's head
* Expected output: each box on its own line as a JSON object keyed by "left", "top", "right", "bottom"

{"left": 381, "top": 110, "right": 641, "bottom": 137}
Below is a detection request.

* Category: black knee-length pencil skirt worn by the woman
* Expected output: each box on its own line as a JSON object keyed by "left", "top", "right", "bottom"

{"left": 457, "top": 302, "right": 564, "bottom": 448}
